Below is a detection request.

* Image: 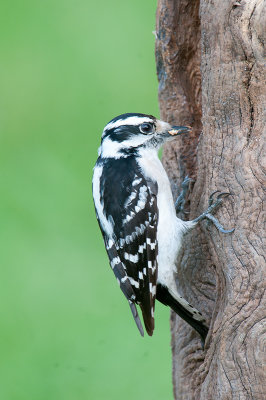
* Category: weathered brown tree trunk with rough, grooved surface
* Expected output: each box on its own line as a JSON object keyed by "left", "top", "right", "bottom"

{"left": 156, "top": 0, "right": 266, "bottom": 400}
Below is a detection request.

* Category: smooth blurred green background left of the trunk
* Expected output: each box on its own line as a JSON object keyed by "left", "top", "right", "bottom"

{"left": 0, "top": 0, "right": 172, "bottom": 400}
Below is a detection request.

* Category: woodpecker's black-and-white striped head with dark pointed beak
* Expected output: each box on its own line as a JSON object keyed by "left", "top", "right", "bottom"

{"left": 99, "top": 113, "right": 191, "bottom": 158}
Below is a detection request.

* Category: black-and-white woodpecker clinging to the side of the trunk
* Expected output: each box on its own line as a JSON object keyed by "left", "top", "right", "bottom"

{"left": 92, "top": 113, "right": 233, "bottom": 343}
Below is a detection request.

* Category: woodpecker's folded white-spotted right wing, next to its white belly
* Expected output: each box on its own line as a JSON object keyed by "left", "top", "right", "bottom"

{"left": 117, "top": 178, "right": 158, "bottom": 335}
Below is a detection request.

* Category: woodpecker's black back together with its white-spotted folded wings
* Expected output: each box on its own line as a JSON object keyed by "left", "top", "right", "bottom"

{"left": 95, "top": 158, "right": 158, "bottom": 335}
